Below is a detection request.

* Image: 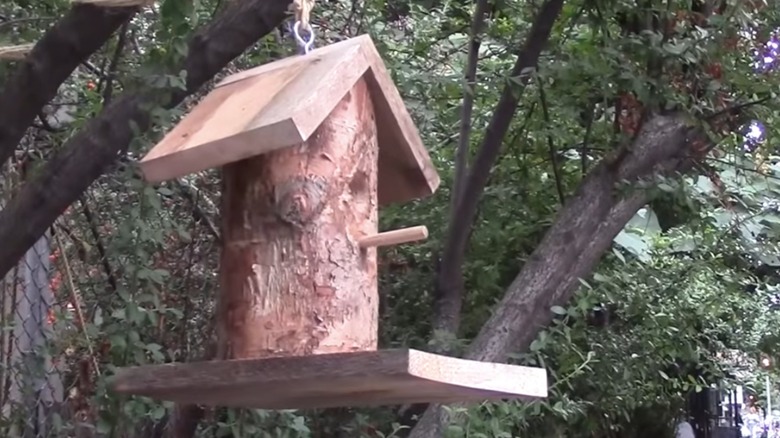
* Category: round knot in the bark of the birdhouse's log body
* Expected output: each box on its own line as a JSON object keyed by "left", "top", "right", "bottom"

{"left": 274, "top": 175, "right": 328, "bottom": 227}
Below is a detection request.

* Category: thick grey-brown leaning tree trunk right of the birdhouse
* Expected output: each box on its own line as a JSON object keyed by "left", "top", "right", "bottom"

{"left": 410, "top": 116, "right": 706, "bottom": 438}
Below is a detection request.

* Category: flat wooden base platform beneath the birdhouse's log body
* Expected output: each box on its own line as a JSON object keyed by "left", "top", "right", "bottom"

{"left": 113, "top": 349, "right": 547, "bottom": 409}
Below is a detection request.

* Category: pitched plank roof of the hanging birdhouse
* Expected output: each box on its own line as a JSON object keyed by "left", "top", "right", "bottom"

{"left": 140, "top": 35, "right": 440, "bottom": 204}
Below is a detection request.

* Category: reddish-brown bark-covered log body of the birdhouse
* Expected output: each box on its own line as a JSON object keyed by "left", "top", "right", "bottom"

{"left": 217, "top": 80, "right": 379, "bottom": 359}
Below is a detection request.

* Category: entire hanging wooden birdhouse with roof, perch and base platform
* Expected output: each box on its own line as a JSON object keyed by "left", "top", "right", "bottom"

{"left": 114, "top": 36, "right": 547, "bottom": 409}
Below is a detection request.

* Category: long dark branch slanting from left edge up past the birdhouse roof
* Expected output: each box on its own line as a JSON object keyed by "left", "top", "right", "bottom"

{"left": 0, "top": 0, "right": 290, "bottom": 277}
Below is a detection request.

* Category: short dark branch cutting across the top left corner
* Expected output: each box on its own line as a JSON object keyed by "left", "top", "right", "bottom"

{"left": 0, "top": 4, "right": 138, "bottom": 166}
